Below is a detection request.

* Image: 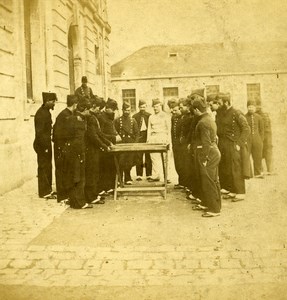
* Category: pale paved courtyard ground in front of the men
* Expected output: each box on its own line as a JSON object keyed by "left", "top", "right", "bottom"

{"left": 0, "top": 120, "right": 287, "bottom": 300}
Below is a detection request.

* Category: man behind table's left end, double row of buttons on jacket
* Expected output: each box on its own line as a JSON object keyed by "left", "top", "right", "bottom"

{"left": 115, "top": 102, "right": 139, "bottom": 184}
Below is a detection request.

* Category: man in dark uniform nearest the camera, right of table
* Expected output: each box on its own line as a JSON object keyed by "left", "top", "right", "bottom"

{"left": 192, "top": 100, "right": 221, "bottom": 217}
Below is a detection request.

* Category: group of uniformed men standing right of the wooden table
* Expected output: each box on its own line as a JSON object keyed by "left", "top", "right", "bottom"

{"left": 168, "top": 89, "right": 272, "bottom": 217}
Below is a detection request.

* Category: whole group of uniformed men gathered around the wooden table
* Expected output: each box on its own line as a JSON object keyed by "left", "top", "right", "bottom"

{"left": 34, "top": 76, "right": 272, "bottom": 217}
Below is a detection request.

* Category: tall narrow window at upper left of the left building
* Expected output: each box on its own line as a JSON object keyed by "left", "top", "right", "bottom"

{"left": 24, "top": 1, "right": 33, "bottom": 99}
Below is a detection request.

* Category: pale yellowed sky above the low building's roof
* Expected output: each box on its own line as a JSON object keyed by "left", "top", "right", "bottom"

{"left": 107, "top": 0, "right": 287, "bottom": 64}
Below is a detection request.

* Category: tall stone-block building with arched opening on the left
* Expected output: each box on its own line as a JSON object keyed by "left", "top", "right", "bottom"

{"left": 0, "top": 0, "right": 111, "bottom": 193}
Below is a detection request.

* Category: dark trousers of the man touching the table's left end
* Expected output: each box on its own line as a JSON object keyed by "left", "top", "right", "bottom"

{"left": 99, "top": 152, "right": 116, "bottom": 191}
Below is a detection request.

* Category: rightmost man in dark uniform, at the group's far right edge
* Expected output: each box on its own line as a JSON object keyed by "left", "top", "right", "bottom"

{"left": 256, "top": 105, "right": 273, "bottom": 175}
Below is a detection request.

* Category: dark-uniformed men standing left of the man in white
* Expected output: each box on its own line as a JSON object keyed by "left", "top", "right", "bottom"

{"left": 34, "top": 88, "right": 154, "bottom": 208}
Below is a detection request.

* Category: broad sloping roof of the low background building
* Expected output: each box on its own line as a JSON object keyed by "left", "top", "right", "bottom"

{"left": 111, "top": 42, "right": 287, "bottom": 79}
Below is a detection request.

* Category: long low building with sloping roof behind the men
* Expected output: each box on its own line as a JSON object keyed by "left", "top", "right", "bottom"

{"left": 111, "top": 42, "right": 287, "bottom": 115}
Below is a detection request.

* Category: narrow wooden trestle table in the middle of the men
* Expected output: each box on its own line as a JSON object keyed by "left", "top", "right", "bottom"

{"left": 111, "top": 143, "right": 169, "bottom": 200}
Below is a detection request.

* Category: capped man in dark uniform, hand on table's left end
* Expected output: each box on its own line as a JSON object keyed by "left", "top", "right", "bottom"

{"left": 97, "top": 98, "right": 121, "bottom": 195}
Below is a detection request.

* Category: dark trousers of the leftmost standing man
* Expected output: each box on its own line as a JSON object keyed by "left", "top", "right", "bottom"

{"left": 37, "top": 149, "right": 52, "bottom": 197}
